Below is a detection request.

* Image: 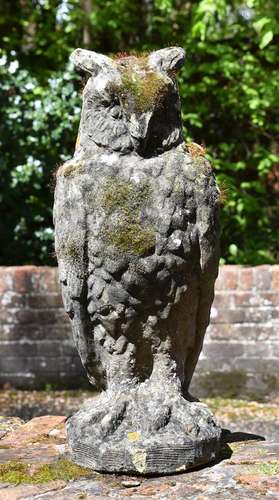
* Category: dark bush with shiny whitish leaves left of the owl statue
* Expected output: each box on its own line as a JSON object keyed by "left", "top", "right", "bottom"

{"left": 0, "top": 53, "right": 80, "bottom": 265}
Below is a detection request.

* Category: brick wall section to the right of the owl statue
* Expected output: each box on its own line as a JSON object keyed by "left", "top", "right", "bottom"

{"left": 192, "top": 265, "right": 279, "bottom": 398}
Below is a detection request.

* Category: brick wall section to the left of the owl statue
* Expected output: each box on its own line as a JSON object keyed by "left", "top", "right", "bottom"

{"left": 0, "top": 266, "right": 85, "bottom": 389}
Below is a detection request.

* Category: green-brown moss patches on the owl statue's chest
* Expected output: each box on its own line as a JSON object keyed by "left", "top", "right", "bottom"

{"left": 99, "top": 179, "right": 155, "bottom": 255}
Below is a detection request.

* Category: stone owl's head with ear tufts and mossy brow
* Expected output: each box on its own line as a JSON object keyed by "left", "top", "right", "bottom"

{"left": 70, "top": 47, "right": 185, "bottom": 157}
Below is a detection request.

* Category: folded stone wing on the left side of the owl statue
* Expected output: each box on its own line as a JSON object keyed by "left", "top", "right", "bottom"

{"left": 53, "top": 169, "right": 91, "bottom": 383}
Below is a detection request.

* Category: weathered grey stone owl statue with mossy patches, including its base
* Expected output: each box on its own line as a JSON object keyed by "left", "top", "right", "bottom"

{"left": 54, "top": 47, "right": 221, "bottom": 475}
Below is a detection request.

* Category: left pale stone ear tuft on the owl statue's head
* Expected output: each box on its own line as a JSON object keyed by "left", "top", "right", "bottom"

{"left": 70, "top": 49, "right": 113, "bottom": 76}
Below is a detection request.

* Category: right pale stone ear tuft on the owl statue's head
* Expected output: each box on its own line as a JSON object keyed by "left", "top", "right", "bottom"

{"left": 148, "top": 47, "right": 185, "bottom": 73}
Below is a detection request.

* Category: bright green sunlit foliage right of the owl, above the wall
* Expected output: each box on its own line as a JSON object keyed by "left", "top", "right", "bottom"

{"left": 183, "top": 0, "right": 279, "bottom": 264}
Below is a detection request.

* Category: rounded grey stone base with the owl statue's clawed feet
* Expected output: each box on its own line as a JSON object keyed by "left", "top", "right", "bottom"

{"left": 67, "top": 383, "right": 221, "bottom": 475}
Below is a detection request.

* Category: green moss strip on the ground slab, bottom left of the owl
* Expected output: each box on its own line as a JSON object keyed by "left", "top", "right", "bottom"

{"left": 0, "top": 459, "right": 92, "bottom": 484}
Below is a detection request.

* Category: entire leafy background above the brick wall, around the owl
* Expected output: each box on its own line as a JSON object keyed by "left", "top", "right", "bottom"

{"left": 0, "top": 0, "right": 279, "bottom": 265}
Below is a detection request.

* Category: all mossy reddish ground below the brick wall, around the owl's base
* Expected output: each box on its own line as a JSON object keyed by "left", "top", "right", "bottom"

{"left": 0, "top": 390, "right": 279, "bottom": 500}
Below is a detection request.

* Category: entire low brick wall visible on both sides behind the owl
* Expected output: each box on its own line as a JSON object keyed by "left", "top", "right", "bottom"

{"left": 0, "top": 266, "right": 279, "bottom": 396}
